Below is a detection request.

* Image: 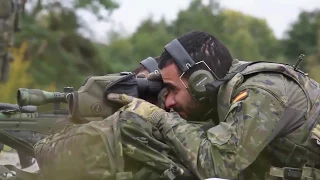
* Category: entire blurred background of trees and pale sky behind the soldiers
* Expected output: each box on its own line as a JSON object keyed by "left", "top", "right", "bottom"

{"left": 0, "top": 0, "right": 320, "bottom": 103}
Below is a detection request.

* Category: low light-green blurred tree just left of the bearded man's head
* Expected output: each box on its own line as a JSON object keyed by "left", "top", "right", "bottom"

{"left": 106, "top": 18, "right": 174, "bottom": 72}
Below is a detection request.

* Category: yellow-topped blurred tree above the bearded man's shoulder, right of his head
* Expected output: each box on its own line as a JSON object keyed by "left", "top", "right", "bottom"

{"left": 217, "top": 9, "right": 280, "bottom": 61}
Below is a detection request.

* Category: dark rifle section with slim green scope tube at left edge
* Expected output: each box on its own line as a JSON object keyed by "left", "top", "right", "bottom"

{"left": 0, "top": 87, "right": 73, "bottom": 158}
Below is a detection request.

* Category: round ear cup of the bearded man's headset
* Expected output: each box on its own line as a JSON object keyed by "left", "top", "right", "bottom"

{"left": 189, "top": 69, "right": 215, "bottom": 95}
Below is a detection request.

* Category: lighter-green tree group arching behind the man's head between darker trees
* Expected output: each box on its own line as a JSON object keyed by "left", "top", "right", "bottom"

{"left": 106, "top": 0, "right": 280, "bottom": 69}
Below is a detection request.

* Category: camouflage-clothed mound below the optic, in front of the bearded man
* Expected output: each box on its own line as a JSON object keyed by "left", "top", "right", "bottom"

{"left": 0, "top": 111, "right": 198, "bottom": 180}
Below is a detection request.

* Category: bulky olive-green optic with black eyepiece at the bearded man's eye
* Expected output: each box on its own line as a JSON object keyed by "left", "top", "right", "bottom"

{"left": 68, "top": 73, "right": 163, "bottom": 120}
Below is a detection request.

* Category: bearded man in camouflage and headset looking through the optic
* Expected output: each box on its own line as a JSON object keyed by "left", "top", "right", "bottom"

{"left": 109, "top": 31, "right": 320, "bottom": 180}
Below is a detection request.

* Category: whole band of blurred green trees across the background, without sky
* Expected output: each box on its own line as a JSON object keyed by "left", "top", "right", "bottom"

{"left": 4, "top": 0, "right": 320, "bottom": 102}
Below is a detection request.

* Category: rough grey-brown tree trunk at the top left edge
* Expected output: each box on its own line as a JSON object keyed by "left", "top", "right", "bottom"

{"left": 0, "top": 0, "right": 20, "bottom": 82}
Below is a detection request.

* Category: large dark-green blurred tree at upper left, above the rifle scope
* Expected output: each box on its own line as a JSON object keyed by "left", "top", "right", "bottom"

{"left": 15, "top": 0, "right": 118, "bottom": 89}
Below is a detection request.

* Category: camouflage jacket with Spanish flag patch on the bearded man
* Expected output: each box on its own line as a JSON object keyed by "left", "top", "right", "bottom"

{"left": 144, "top": 60, "right": 320, "bottom": 180}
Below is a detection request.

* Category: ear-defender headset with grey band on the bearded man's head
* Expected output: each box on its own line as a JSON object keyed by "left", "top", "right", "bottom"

{"left": 164, "top": 39, "right": 219, "bottom": 101}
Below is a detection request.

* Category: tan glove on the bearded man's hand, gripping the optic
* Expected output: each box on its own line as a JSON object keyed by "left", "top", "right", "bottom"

{"left": 107, "top": 93, "right": 166, "bottom": 125}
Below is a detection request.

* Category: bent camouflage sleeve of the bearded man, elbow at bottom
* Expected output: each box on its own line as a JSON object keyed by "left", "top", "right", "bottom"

{"left": 158, "top": 87, "right": 284, "bottom": 179}
